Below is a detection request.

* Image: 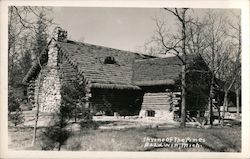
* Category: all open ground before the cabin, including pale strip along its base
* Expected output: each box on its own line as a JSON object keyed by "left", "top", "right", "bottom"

{"left": 9, "top": 118, "right": 241, "bottom": 152}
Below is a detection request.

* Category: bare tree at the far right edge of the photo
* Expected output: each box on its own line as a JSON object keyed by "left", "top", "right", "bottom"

{"left": 220, "top": 12, "right": 241, "bottom": 125}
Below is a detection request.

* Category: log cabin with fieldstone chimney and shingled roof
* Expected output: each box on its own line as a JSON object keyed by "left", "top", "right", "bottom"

{"left": 23, "top": 27, "right": 212, "bottom": 120}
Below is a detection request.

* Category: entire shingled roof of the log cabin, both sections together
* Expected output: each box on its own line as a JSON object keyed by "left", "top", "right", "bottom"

{"left": 23, "top": 32, "right": 204, "bottom": 89}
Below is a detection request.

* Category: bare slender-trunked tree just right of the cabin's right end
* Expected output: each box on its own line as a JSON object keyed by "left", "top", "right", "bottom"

{"left": 200, "top": 10, "right": 231, "bottom": 125}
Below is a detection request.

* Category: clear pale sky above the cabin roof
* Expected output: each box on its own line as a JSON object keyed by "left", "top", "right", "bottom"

{"left": 53, "top": 7, "right": 240, "bottom": 51}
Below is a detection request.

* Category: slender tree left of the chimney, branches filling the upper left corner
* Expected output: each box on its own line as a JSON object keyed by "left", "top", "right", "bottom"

{"left": 8, "top": 6, "right": 52, "bottom": 144}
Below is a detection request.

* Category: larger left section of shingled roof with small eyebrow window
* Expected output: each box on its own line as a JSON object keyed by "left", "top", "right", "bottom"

{"left": 23, "top": 40, "right": 152, "bottom": 89}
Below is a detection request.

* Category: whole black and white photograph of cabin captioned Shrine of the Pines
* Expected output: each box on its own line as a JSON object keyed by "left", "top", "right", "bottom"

{"left": 1, "top": 1, "right": 250, "bottom": 157}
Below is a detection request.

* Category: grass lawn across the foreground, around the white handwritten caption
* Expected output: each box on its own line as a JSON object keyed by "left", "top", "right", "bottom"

{"left": 9, "top": 123, "right": 241, "bottom": 152}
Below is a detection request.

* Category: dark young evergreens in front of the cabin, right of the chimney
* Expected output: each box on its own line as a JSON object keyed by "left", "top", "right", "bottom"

{"left": 39, "top": 81, "right": 87, "bottom": 151}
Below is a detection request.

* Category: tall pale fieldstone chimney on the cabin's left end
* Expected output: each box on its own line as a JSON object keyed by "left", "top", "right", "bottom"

{"left": 34, "top": 28, "right": 67, "bottom": 112}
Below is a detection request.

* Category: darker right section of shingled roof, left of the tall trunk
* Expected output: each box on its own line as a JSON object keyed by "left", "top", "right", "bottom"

{"left": 132, "top": 55, "right": 196, "bottom": 86}
